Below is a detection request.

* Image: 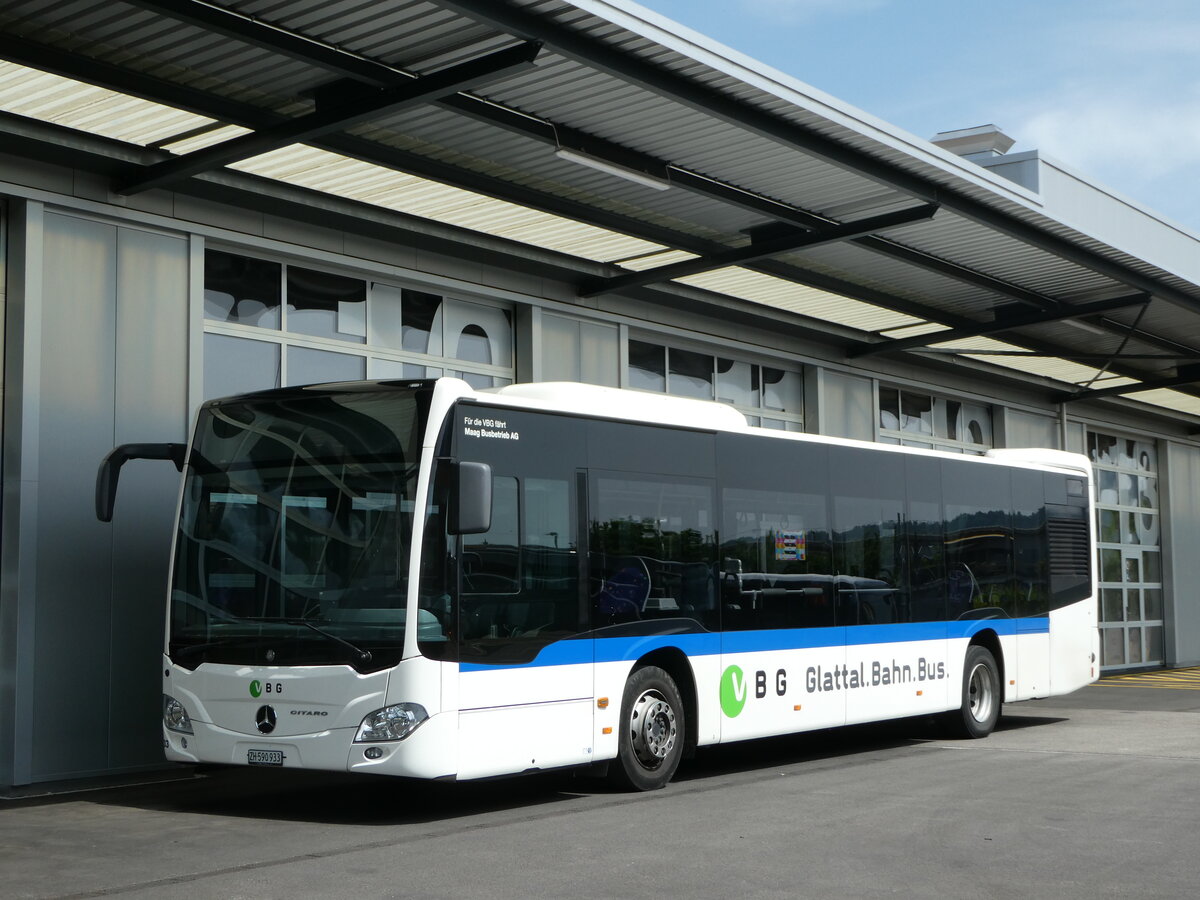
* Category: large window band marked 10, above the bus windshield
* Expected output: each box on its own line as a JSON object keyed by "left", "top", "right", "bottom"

{"left": 204, "top": 250, "right": 512, "bottom": 398}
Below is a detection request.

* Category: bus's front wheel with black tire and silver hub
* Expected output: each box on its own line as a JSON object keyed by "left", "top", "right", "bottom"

{"left": 608, "top": 666, "right": 686, "bottom": 791}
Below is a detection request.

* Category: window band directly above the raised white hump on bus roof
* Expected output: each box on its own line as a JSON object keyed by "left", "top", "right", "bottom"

{"left": 629, "top": 340, "right": 804, "bottom": 431}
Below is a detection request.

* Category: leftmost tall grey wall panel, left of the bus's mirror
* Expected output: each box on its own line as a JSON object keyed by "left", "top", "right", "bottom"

{"left": 34, "top": 215, "right": 116, "bottom": 780}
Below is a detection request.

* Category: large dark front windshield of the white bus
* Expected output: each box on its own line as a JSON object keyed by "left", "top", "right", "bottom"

{"left": 168, "top": 385, "right": 437, "bottom": 671}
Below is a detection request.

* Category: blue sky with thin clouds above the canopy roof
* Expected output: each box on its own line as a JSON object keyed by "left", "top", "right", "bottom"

{"left": 640, "top": 0, "right": 1200, "bottom": 233}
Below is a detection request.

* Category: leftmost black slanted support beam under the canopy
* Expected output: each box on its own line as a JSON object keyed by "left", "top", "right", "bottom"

{"left": 115, "top": 43, "right": 541, "bottom": 194}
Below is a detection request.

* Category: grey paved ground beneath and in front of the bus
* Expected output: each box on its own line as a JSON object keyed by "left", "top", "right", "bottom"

{"left": 0, "top": 673, "right": 1200, "bottom": 900}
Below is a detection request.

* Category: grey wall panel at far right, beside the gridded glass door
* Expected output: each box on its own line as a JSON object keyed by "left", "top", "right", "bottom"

{"left": 1163, "top": 443, "right": 1200, "bottom": 666}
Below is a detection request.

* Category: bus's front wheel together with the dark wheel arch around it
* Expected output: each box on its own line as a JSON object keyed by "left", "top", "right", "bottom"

{"left": 608, "top": 650, "right": 696, "bottom": 791}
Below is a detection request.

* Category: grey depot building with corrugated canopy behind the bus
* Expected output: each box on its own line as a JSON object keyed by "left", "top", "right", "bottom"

{"left": 0, "top": 0, "right": 1200, "bottom": 785}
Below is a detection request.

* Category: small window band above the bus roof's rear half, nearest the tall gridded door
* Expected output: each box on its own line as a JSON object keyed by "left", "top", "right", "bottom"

{"left": 880, "top": 386, "right": 992, "bottom": 454}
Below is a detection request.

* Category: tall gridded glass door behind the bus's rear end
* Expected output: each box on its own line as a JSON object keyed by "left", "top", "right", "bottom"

{"left": 1087, "top": 431, "right": 1163, "bottom": 670}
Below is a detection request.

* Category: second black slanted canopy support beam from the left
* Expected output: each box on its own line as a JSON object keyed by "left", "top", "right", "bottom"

{"left": 580, "top": 204, "right": 937, "bottom": 298}
